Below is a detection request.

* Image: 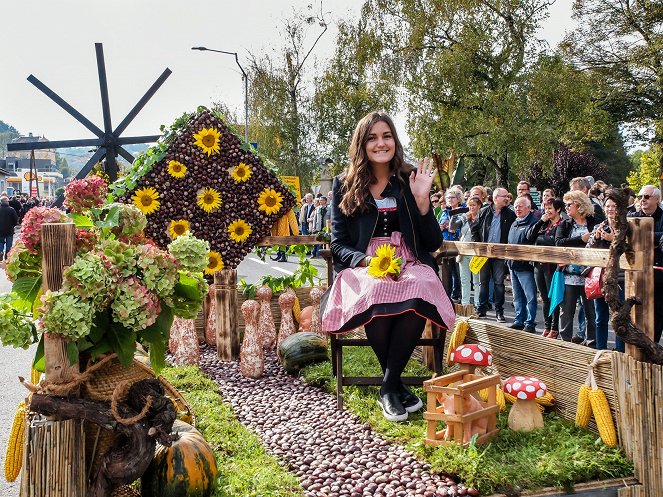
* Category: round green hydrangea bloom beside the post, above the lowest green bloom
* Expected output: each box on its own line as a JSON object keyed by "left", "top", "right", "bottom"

{"left": 62, "top": 252, "right": 114, "bottom": 309}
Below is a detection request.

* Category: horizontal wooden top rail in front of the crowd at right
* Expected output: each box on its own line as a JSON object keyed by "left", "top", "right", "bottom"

{"left": 433, "top": 239, "right": 648, "bottom": 271}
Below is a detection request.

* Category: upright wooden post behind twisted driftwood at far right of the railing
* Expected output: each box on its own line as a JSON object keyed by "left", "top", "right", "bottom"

{"left": 625, "top": 217, "right": 661, "bottom": 361}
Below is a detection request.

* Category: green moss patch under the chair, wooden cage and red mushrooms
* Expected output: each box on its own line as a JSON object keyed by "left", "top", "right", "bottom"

{"left": 301, "top": 347, "right": 633, "bottom": 495}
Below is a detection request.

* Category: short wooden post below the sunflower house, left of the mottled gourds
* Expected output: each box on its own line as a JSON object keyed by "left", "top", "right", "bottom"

{"left": 214, "top": 269, "right": 239, "bottom": 361}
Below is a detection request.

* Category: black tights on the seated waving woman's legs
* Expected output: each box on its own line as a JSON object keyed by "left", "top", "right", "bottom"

{"left": 364, "top": 312, "right": 426, "bottom": 394}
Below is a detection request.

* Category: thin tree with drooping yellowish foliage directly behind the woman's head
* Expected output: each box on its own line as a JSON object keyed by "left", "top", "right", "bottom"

{"left": 313, "top": 18, "right": 397, "bottom": 174}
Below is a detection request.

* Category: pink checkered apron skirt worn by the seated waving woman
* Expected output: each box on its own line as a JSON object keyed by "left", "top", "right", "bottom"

{"left": 322, "top": 231, "right": 456, "bottom": 333}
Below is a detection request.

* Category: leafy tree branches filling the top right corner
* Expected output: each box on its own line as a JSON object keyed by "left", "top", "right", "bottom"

{"left": 562, "top": 0, "right": 663, "bottom": 189}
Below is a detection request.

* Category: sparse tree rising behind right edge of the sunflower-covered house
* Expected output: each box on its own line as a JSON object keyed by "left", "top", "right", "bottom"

{"left": 249, "top": 6, "right": 327, "bottom": 188}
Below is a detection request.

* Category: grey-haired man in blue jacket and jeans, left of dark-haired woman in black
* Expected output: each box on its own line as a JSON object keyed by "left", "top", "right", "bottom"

{"left": 507, "top": 196, "right": 537, "bottom": 333}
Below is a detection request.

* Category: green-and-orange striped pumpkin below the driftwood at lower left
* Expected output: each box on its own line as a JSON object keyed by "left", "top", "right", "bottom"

{"left": 140, "top": 420, "right": 218, "bottom": 497}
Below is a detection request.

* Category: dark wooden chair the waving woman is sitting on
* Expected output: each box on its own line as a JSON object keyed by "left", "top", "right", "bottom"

{"left": 320, "top": 250, "right": 447, "bottom": 409}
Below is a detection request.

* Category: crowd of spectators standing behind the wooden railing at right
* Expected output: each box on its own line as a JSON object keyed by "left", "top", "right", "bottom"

{"left": 431, "top": 177, "right": 663, "bottom": 351}
